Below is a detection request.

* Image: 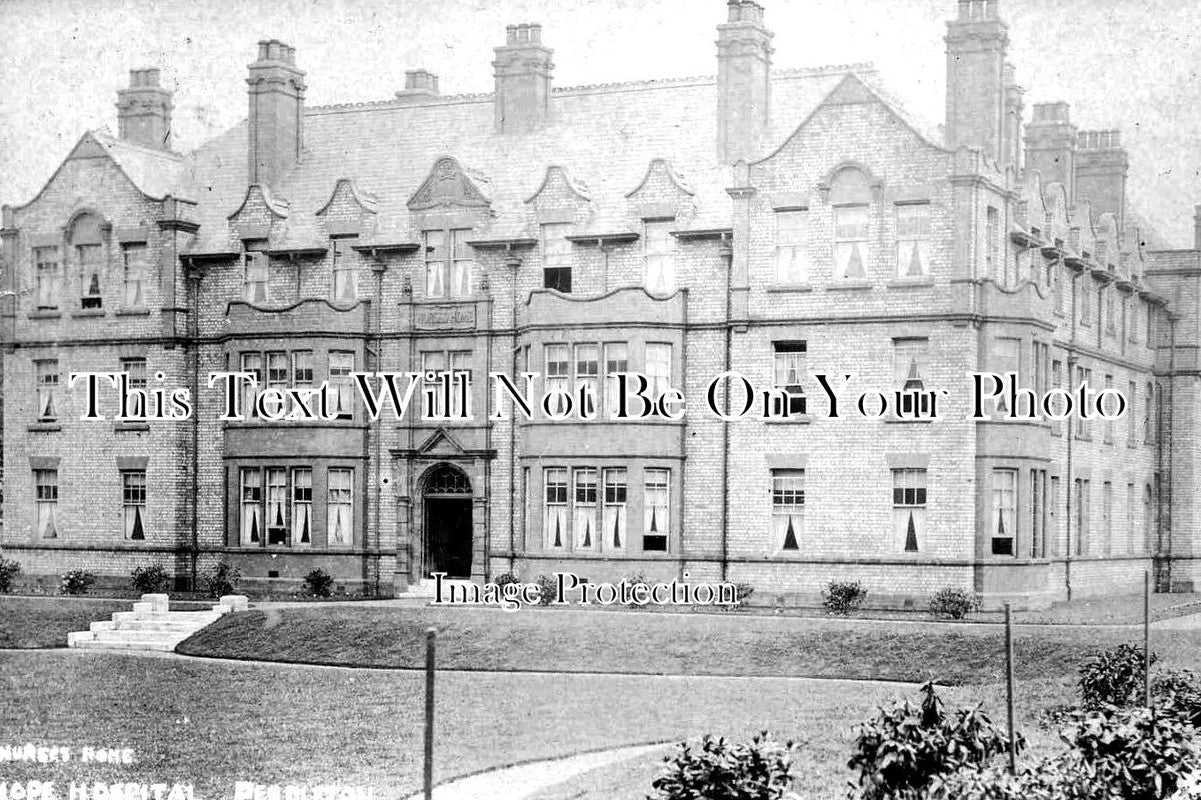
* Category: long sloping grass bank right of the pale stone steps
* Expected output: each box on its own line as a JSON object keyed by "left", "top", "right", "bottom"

{"left": 179, "top": 605, "right": 1201, "bottom": 683}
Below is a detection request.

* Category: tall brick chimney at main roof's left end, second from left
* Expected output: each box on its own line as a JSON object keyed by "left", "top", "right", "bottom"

{"left": 246, "top": 38, "right": 305, "bottom": 186}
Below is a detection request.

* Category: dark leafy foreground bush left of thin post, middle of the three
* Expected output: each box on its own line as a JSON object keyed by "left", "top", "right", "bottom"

{"left": 847, "top": 683, "right": 1026, "bottom": 800}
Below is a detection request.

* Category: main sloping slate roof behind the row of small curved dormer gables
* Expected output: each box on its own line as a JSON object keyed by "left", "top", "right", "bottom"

{"left": 175, "top": 65, "right": 903, "bottom": 251}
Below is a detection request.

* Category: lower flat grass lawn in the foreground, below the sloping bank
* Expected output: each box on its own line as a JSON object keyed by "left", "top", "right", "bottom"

{"left": 0, "top": 651, "right": 1071, "bottom": 800}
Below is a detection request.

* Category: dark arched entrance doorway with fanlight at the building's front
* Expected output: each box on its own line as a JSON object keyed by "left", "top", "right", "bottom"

{"left": 422, "top": 464, "right": 472, "bottom": 578}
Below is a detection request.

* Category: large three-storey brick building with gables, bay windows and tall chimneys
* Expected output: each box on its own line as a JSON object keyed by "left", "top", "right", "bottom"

{"left": 0, "top": 0, "right": 1201, "bottom": 605}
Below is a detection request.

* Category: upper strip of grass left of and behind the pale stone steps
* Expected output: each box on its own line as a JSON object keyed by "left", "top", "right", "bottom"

{"left": 0, "top": 596, "right": 213, "bottom": 650}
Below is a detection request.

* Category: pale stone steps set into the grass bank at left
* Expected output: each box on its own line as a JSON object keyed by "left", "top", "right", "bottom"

{"left": 67, "top": 595, "right": 249, "bottom": 652}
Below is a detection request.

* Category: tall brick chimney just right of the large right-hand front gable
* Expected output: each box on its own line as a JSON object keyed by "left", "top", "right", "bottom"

{"left": 946, "top": 0, "right": 1009, "bottom": 162}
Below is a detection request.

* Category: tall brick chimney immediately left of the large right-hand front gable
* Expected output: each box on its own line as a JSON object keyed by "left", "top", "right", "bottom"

{"left": 717, "top": 0, "right": 773, "bottom": 163}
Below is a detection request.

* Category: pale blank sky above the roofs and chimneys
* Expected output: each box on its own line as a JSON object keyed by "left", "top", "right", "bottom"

{"left": 0, "top": 0, "right": 1201, "bottom": 247}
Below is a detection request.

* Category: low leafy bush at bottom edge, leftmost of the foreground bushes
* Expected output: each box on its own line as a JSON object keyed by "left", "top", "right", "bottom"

{"left": 651, "top": 732, "right": 795, "bottom": 800}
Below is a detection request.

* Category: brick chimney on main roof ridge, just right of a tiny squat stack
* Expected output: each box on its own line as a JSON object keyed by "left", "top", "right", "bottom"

{"left": 492, "top": 23, "right": 555, "bottom": 133}
